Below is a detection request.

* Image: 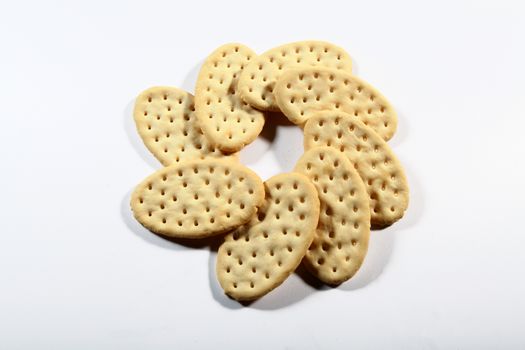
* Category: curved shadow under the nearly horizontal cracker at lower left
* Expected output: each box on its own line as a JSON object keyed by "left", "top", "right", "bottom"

{"left": 120, "top": 190, "right": 222, "bottom": 251}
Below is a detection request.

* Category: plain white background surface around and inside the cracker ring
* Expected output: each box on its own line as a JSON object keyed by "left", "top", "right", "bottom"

{"left": 0, "top": 0, "right": 525, "bottom": 349}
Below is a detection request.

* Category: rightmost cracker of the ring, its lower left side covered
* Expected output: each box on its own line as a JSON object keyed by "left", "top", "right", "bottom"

{"left": 304, "top": 111, "right": 409, "bottom": 227}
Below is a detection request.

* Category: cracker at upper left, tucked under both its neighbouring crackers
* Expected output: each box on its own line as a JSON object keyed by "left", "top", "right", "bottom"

{"left": 133, "top": 86, "right": 231, "bottom": 166}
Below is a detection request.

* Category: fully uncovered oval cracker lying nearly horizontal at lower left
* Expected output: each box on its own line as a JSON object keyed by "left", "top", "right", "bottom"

{"left": 131, "top": 158, "right": 264, "bottom": 238}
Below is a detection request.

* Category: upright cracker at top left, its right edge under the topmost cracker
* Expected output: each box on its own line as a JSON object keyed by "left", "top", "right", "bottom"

{"left": 195, "top": 44, "right": 264, "bottom": 152}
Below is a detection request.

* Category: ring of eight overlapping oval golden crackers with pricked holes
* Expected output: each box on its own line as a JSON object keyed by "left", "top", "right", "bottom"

{"left": 131, "top": 41, "right": 409, "bottom": 301}
